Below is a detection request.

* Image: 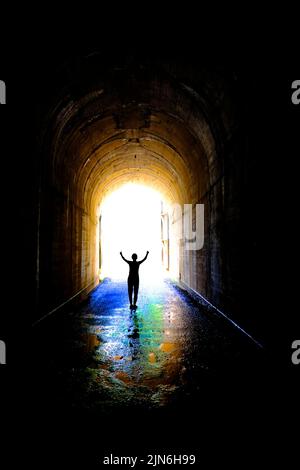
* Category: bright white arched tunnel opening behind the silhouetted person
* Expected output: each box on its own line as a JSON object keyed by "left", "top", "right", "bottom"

{"left": 99, "top": 183, "right": 163, "bottom": 283}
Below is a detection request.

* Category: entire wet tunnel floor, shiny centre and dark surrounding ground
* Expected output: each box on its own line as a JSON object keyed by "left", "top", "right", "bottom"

{"left": 30, "top": 282, "right": 288, "bottom": 468}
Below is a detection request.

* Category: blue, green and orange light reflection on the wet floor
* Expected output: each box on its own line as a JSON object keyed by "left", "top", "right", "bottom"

{"left": 76, "top": 282, "right": 185, "bottom": 405}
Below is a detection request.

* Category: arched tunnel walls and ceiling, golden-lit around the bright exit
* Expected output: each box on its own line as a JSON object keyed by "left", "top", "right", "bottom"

{"left": 35, "top": 54, "right": 251, "bottom": 330}
